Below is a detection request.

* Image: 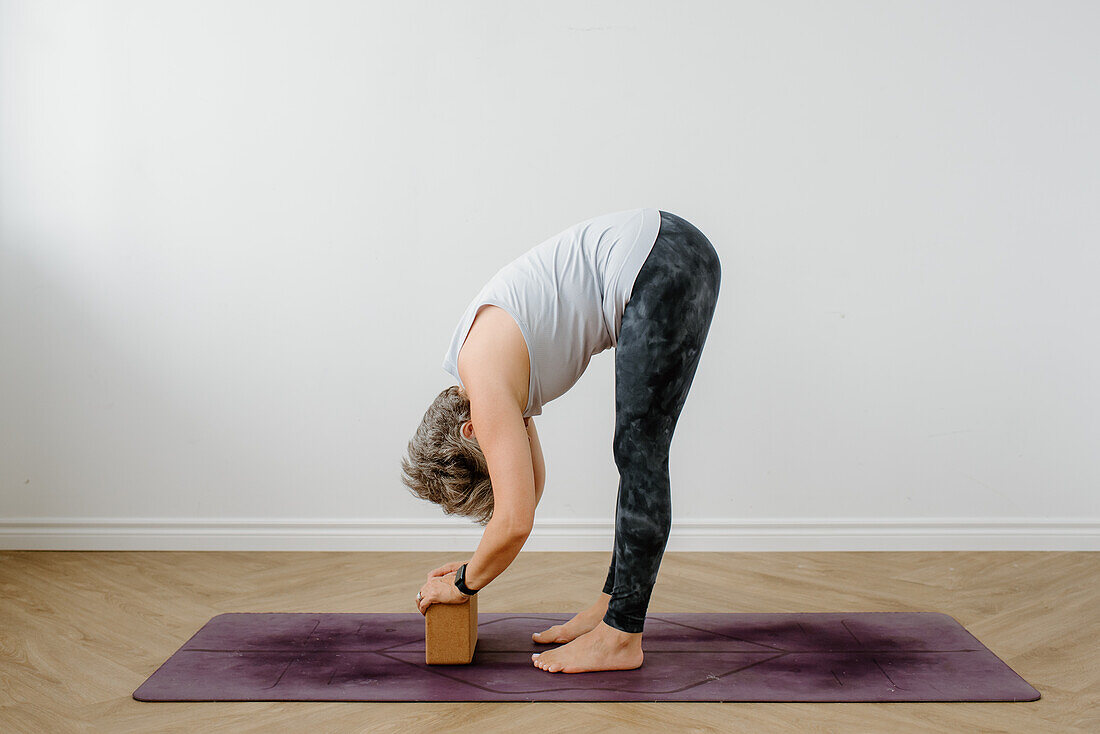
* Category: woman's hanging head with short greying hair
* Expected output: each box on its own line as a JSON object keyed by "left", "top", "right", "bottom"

{"left": 402, "top": 385, "right": 493, "bottom": 525}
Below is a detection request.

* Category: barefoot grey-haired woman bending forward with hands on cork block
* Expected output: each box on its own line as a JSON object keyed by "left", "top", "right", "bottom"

{"left": 402, "top": 208, "right": 722, "bottom": 672}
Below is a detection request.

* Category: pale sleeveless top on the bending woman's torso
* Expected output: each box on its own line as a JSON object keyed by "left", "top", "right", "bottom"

{"left": 443, "top": 208, "right": 661, "bottom": 418}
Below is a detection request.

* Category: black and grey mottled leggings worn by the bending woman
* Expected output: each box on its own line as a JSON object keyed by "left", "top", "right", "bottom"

{"left": 604, "top": 211, "right": 722, "bottom": 632}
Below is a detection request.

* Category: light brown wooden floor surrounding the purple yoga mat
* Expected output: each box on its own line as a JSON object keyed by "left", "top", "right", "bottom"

{"left": 0, "top": 551, "right": 1100, "bottom": 734}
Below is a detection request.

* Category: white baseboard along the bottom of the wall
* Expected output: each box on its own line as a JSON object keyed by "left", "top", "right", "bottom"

{"left": 0, "top": 518, "right": 1100, "bottom": 552}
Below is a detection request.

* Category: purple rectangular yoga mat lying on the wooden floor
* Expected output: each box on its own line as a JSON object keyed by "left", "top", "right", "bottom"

{"left": 133, "top": 612, "right": 1040, "bottom": 701}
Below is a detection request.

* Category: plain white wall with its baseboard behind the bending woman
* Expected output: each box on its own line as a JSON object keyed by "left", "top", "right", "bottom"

{"left": 0, "top": 0, "right": 1100, "bottom": 550}
